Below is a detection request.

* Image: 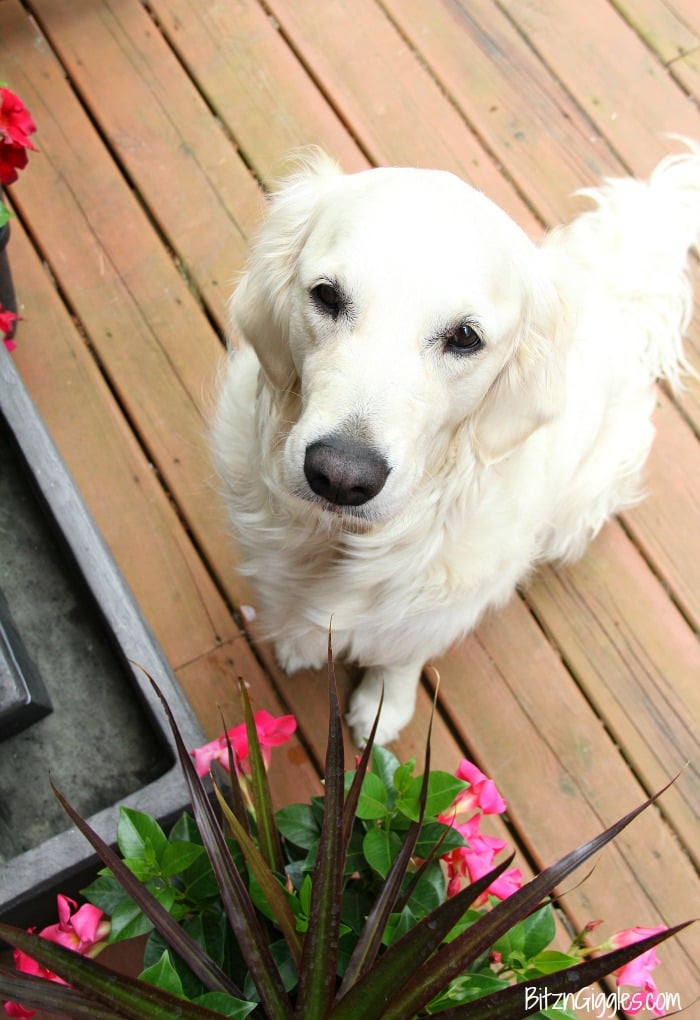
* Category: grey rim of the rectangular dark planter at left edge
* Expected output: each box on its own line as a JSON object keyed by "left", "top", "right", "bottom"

{"left": 0, "top": 344, "right": 205, "bottom": 918}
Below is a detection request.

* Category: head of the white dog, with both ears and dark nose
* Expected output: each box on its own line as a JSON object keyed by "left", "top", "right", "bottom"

{"left": 232, "top": 155, "right": 563, "bottom": 521}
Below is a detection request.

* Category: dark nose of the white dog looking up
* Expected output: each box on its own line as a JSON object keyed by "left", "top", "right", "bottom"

{"left": 304, "top": 439, "right": 391, "bottom": 507}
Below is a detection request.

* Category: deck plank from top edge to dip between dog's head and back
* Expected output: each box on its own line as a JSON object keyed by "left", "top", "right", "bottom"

{"left": 268, "top": 0, "right": 537, "bottom": 230}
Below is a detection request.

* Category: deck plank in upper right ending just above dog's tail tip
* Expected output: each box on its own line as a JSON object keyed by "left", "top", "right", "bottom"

{"left": 501, "top": 0, "right": 700, "bottom": 175}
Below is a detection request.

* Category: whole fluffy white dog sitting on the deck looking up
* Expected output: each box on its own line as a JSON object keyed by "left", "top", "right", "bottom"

{"left": 214, "top": 148, "right": 700, "bottom": 743}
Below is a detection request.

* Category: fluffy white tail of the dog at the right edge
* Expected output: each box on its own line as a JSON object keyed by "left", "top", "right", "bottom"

{"left": 564, "top": 139, "right": 700, "bottom": 386}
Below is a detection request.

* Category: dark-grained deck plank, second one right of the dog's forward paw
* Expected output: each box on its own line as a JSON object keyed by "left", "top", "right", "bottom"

{"left": 527, "top": 522, "right": 700, "bottom": 860}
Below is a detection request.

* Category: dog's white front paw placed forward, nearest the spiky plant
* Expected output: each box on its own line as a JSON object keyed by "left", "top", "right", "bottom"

{"left": 346, "top": 666, "right": 418, "bottom": 748}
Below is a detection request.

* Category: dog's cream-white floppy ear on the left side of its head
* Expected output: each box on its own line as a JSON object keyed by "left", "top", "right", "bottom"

{"left": 230, "top": 149, "right": 341, "bottom": 390}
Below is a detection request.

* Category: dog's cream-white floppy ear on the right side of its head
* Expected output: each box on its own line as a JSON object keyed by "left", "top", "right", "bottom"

{"left": 470, "top": 269, "right": 566, "bottom": 464}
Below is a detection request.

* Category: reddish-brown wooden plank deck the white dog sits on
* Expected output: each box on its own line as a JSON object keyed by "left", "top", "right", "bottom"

{"left": 0, "top": 0, "right": 700, "bottom": 1017}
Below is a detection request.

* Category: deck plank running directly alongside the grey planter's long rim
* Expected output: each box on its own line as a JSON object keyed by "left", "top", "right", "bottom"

{"left": 8, "top": 219, "right": 236, "bottom": 667}
